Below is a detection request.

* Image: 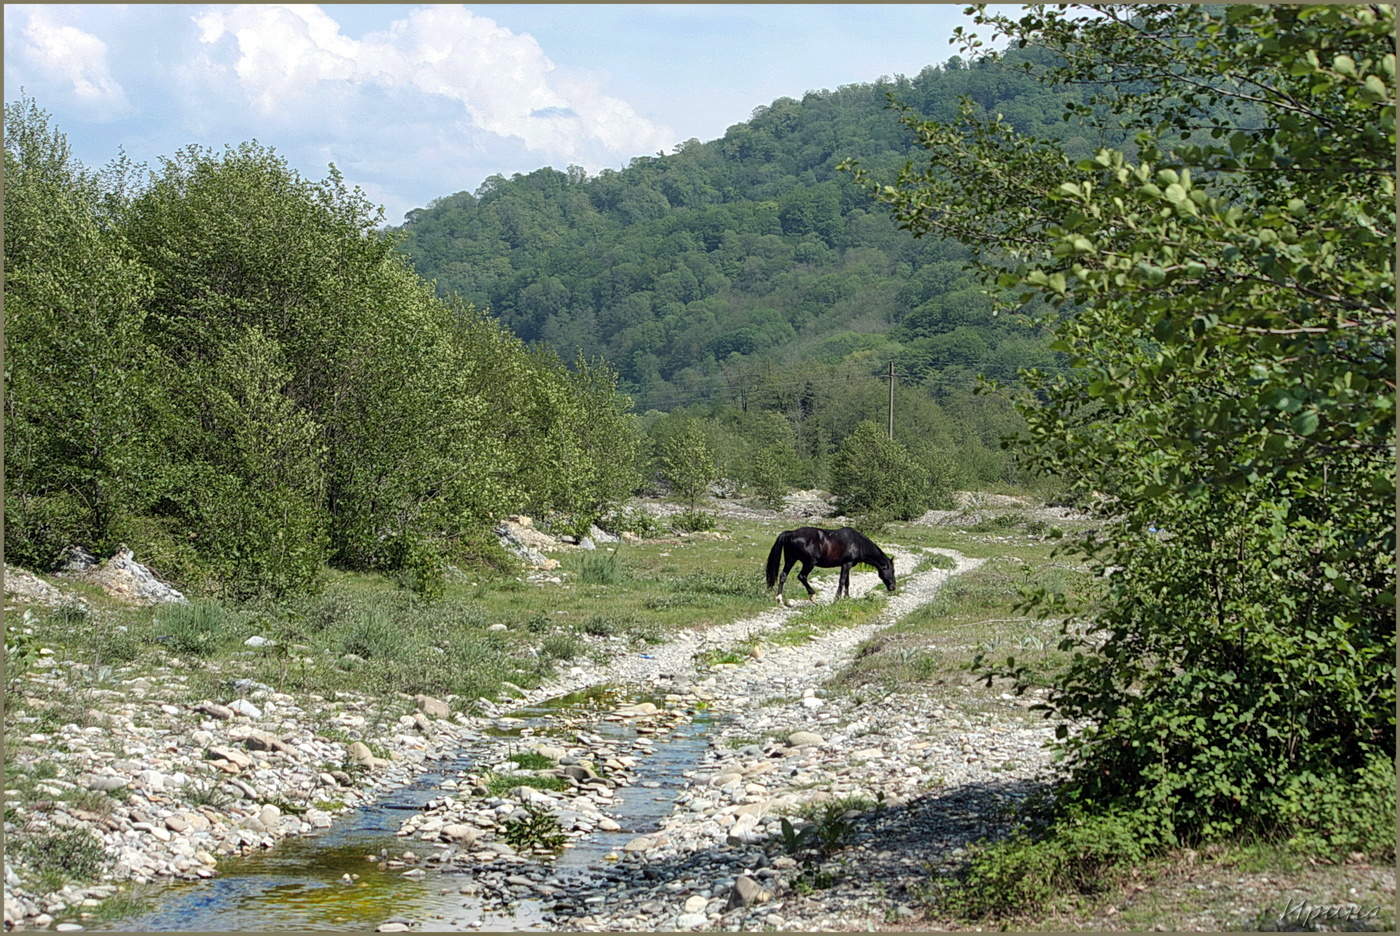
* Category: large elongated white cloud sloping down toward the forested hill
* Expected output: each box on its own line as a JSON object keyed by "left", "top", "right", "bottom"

{"left": 195, "top": 4, "right": 675, "bottom": 168}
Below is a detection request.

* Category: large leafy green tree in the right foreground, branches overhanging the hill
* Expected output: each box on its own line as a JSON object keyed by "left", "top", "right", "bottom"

{"left": 857, "top": 6, "right": 1394, "bottom": 889}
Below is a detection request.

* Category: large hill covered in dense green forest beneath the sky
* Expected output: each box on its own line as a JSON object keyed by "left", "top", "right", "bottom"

{"left": 403, "top": 49, "right": 1121, "bottom": 409}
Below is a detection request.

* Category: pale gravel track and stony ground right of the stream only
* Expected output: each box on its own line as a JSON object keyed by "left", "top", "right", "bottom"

{"left": 453, "top": 550, "right": 1050, "bottom": 932}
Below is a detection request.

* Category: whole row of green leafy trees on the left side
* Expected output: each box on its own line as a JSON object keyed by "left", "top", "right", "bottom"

{"left": 6, "top": 101, "right": 641, "bottom": 597}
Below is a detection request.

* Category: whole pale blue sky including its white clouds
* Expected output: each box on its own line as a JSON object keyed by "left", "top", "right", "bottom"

{"left": 4, "top": 4, "right": 1008, "bottom": 224}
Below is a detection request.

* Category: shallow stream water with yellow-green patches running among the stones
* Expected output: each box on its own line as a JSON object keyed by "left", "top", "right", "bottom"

{"left": 102, "top": 695, "right": 713, "bottom": 932}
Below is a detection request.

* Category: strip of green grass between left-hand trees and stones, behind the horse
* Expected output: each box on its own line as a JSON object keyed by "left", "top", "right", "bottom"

{"left": 2, "top": 514, "right": 776, "bottom": 710}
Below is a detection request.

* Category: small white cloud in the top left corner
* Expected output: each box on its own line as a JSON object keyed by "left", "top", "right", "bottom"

{"left": 20, "top": 7, "right": 130, "bottom": 119}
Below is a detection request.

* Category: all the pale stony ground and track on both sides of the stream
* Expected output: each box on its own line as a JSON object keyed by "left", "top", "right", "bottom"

{"left": 4, "top": 547, "right": 1047, "bottom": 930}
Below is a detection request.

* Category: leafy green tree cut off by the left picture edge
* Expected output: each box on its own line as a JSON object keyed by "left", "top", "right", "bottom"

{"left": 4, "top": 99, "right": 151, "bottom": 568}
